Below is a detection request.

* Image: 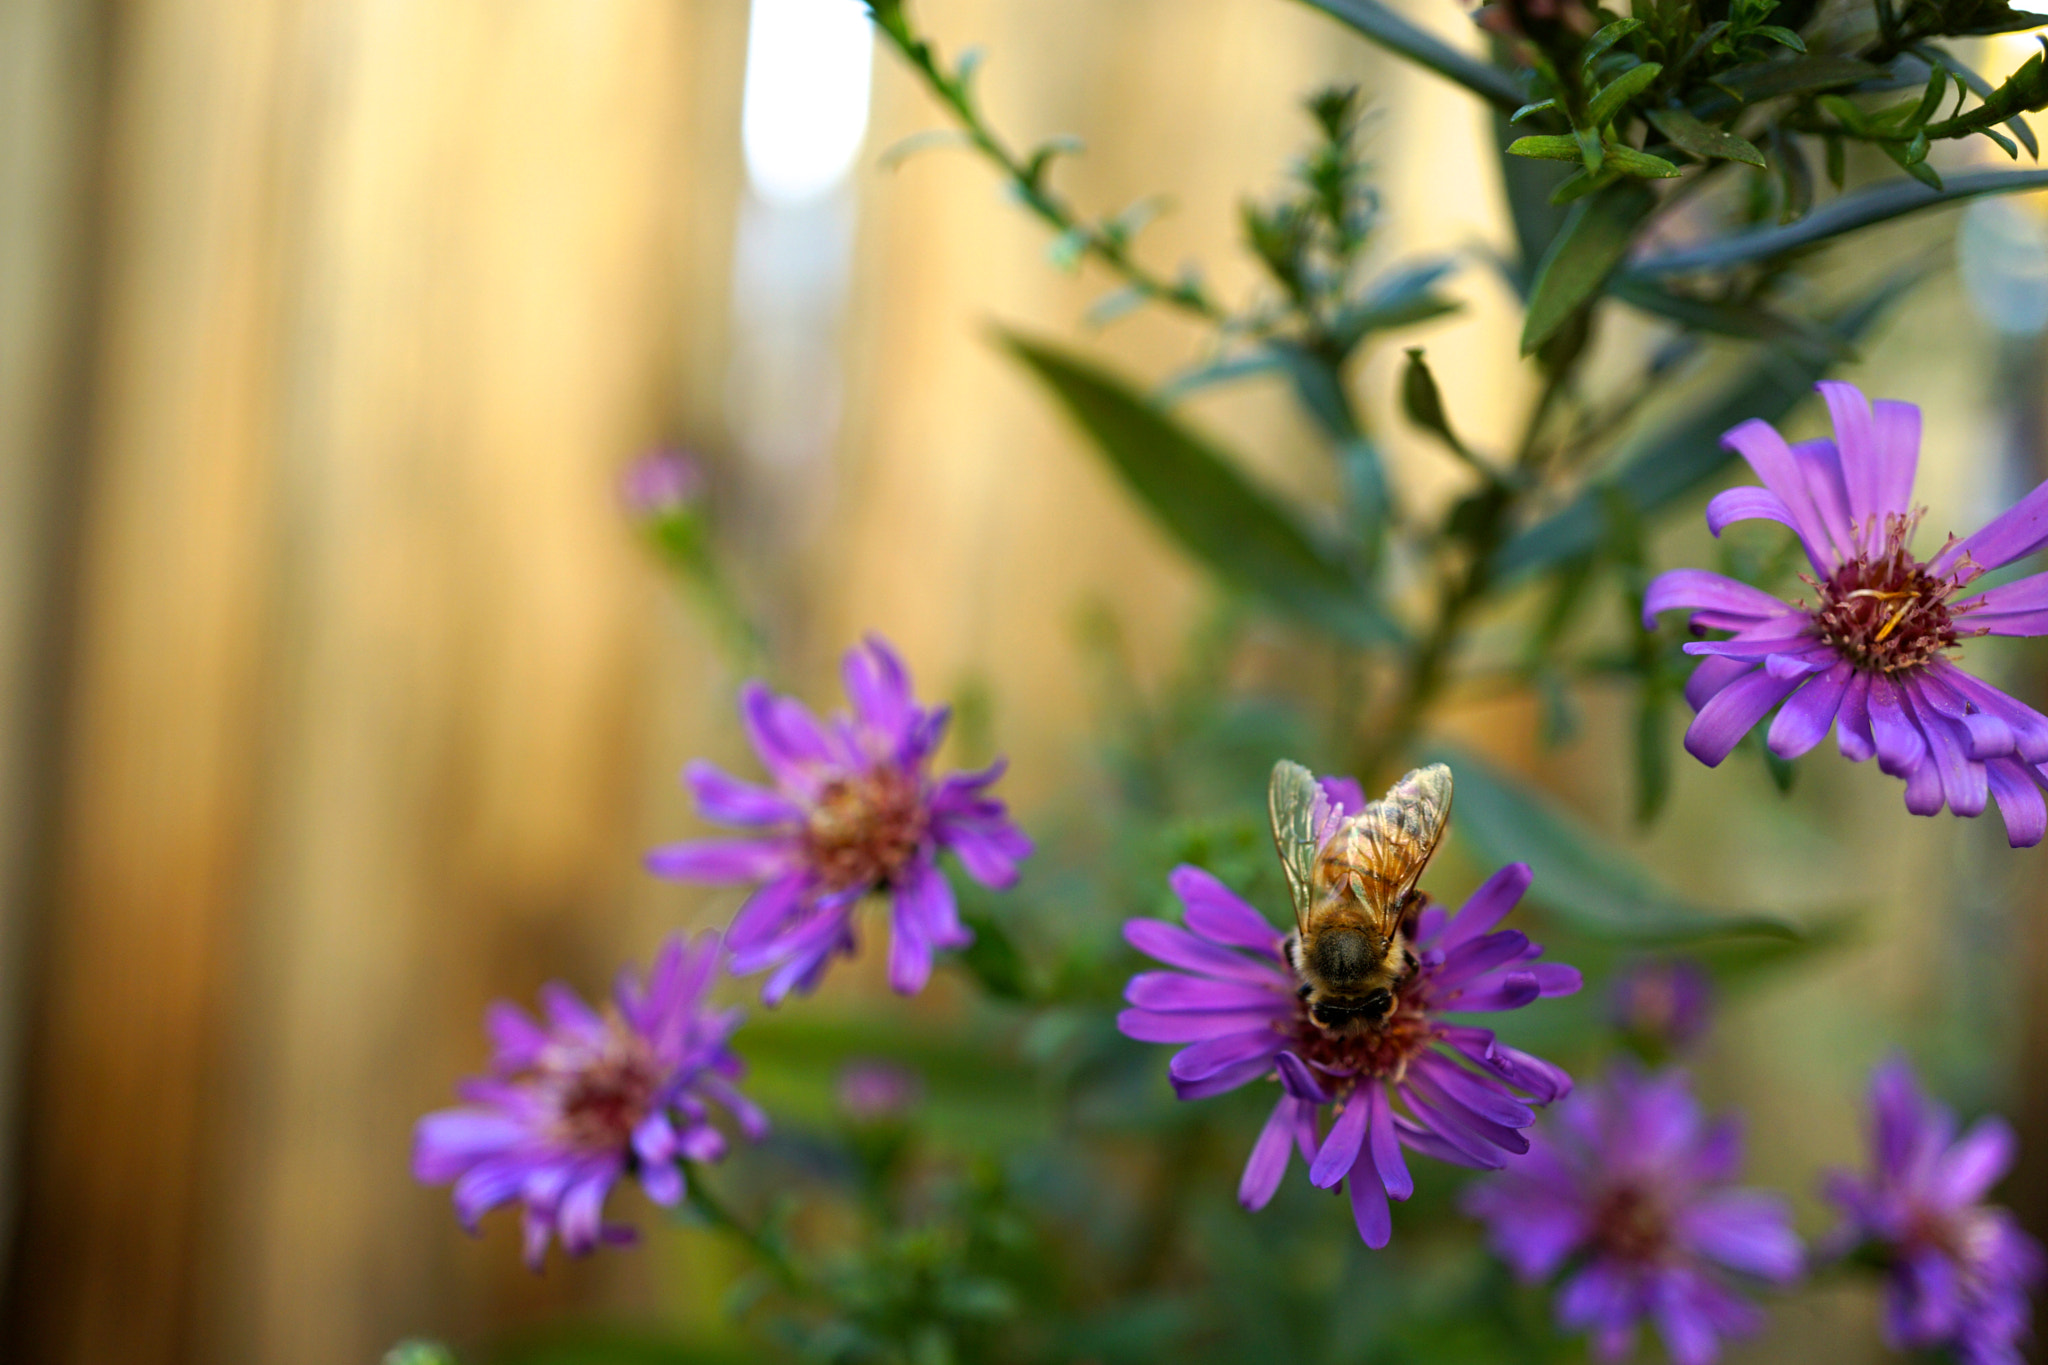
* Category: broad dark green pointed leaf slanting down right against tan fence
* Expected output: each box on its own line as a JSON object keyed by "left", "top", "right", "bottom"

{"left": 1001, "top": 334, "right": 1401, "bottom": 643}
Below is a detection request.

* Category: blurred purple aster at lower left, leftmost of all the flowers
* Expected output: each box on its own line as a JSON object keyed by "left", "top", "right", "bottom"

{"left": 412, "top": 933, "right": 768, "bottom": 1271}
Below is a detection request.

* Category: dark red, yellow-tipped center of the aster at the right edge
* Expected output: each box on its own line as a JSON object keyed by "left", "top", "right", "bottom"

{"left": 1806, "top": 510, "right": 1978, "bottom": 673}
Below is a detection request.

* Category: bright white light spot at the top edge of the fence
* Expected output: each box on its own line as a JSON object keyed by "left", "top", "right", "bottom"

{"left": 739, "top": 0, "right": 874, "bottom": 203}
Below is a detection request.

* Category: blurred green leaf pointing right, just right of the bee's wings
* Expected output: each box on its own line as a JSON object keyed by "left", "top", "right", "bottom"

{"left": 1427, "top": 749, "right": 1802, "bottom": 945}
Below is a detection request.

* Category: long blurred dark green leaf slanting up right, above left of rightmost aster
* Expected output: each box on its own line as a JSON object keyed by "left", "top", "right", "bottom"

{"left": 1493, "top": 276, "right": 1917, "bottom": 579}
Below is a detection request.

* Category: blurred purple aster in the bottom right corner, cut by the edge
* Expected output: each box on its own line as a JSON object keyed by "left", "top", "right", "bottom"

{"left": 1827, "top": 1060, "right": 2044, "bottom": 1365}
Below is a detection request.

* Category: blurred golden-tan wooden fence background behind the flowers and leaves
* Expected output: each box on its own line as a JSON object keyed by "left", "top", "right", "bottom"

{"left": 0, "top": 0, "right": 2048, "bottom": 1365}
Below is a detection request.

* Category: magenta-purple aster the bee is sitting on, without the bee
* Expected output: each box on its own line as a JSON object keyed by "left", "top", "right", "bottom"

{"left": 1116, "top": 859, "right": 1579, "bottom": 1246}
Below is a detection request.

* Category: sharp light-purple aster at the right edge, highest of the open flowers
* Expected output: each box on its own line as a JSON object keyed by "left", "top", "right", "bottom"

{"left": 1642, "top": 383, "right": 2048, "bottom": 847}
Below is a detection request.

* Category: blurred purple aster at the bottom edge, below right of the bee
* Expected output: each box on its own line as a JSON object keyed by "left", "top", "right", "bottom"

{"left": 1464, "top": 1066, "right": 1804, "bottom": 1365}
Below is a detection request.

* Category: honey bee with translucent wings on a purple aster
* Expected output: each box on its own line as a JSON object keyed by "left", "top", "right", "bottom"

{"left": 1266, "top": 759, "right": 1450, "bottom": 1038}
